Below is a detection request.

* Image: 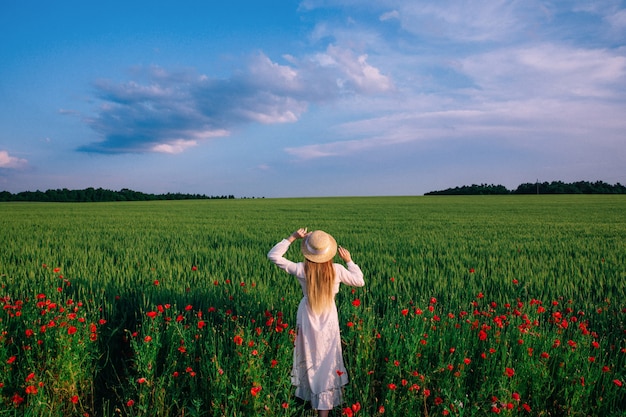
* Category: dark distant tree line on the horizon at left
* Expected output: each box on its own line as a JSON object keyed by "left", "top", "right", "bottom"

{"left": 0, "top": 188, "right": 235, "bottom": 203}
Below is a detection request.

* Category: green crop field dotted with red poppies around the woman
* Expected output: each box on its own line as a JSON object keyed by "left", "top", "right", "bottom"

{"left": 0, "top": 196, "right": 626, "bottom": 417}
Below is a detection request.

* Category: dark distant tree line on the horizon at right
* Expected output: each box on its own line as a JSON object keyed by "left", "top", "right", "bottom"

{"left": 424, "top": 181, "right": 626, "bottom": 195}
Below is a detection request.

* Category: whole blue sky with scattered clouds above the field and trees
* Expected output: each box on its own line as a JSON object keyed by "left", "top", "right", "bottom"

{"left": 0, "top": 0, "right": 626, "bottom": 197}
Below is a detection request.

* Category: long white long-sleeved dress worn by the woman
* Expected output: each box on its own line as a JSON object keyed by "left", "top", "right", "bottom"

{"left": 267, "top": 239, "right": 365, "bottom": 410}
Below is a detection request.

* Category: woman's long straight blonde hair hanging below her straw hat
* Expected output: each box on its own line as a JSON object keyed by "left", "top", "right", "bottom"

{"left": 304, "top": 259, "right": 335, "bottom": 314}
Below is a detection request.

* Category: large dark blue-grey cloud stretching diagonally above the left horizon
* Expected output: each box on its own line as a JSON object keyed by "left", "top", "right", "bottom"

{"left": 78, "top": 47, "right": 391, "bottom": 154}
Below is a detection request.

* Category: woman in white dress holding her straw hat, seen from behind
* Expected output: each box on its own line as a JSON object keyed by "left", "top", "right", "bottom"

{"left": 267, "top": 228, "right": 365, "bottom": 417}
